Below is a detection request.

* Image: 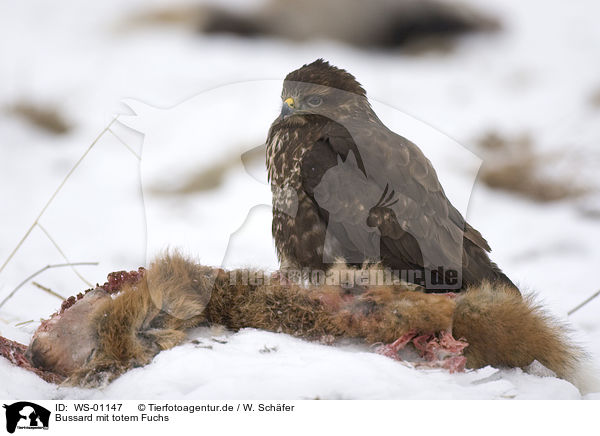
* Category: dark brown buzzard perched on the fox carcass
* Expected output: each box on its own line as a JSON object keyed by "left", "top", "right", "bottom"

{"left": 266, "top": 59, "right": 519, "bottom": 292}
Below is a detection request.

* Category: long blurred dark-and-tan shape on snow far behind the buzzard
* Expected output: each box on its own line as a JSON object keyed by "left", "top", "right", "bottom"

{"left": 130, "top": 0, "right": 499, "bottom": 50}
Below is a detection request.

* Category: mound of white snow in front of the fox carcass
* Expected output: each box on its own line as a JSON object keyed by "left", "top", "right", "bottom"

{"left": 61, "top": 329, "right": 579, "bottom": 399}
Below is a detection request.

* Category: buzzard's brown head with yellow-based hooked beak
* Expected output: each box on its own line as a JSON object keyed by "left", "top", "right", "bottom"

{"left": 280, "top": 59, "right": 370, "bottom": 122}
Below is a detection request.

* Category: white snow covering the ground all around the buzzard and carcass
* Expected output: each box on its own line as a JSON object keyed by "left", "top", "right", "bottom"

{"left": 0, "top": 0, "right": 600, "bottom": 399}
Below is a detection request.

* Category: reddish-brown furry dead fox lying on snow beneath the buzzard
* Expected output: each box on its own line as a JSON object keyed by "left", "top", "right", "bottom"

{"left": 12, "top": 255, "right": 582, "bottom": 386}
